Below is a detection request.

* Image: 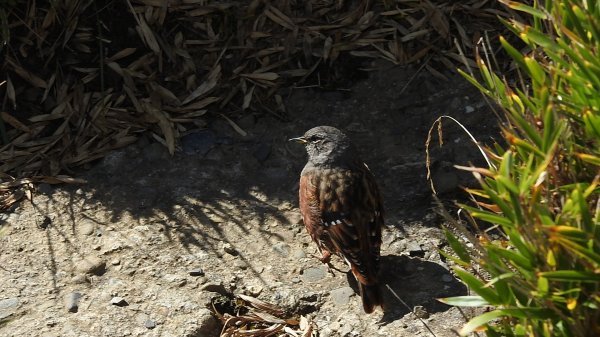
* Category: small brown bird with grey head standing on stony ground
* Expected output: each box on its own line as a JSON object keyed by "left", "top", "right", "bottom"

{"left": 290, "top": 126, "right": 383, "bottom": 313}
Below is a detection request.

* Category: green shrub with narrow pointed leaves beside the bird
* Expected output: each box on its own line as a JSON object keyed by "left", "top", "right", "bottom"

{"left": 442, "top": 0, "right": 600, "bottom": 337}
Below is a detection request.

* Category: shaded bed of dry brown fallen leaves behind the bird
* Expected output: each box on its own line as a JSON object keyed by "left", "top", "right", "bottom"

{"left": 0, "top": 0, "right": 507, "bottom": 207}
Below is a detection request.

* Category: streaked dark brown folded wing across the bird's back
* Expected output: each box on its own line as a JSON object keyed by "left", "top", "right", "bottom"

{"left": 317, "top": 165, "right": 383, "bottom": 284}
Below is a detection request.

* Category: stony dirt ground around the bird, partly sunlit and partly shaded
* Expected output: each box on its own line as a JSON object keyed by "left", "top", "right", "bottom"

{"left": 0, "top": 61, "right": 496, "bottom": 337}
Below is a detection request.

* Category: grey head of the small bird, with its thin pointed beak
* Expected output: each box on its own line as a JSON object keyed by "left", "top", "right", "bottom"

{"left": 290, "top": 126, "right": 357, "bottom": 165}
